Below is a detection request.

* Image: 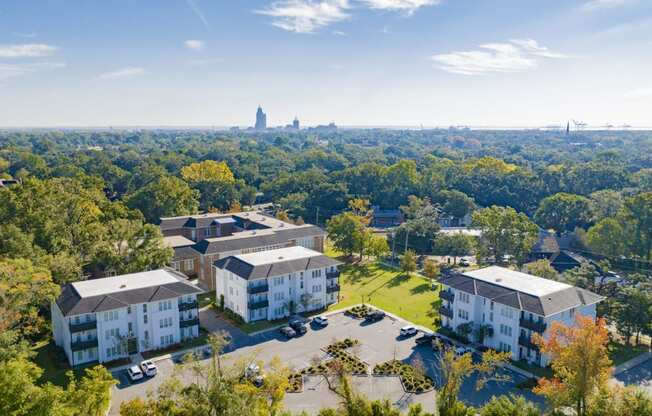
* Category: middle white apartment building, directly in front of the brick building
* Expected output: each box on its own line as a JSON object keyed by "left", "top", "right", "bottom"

{"left": 214, "top": 246, "right": 341, "bottom": 322}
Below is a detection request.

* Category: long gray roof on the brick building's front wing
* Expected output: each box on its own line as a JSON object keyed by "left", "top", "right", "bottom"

{"left": 194, "top": 225, "right": 326, "bottom": 254}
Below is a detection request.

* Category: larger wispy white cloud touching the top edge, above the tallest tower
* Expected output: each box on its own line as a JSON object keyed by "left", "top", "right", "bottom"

{"left": 256, "top": 0, "right": 349, "bottom": 33}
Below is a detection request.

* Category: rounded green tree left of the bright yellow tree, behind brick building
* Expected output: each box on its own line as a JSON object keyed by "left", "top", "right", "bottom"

{"left": 127, "top": 176, "right": 199, "bottom": 223}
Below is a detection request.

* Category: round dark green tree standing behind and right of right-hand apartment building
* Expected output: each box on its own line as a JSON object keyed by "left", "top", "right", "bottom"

{"left": 534, "top": 193, "right": 593, "bottom": 233}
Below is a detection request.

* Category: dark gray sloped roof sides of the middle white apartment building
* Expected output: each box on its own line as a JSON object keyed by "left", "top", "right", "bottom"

{"left": 214, "top": 255, "right": 342, "bottom": 280}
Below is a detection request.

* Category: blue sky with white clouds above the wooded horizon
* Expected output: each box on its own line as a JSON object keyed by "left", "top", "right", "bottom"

{"left": 0, "top": 0, "right": 652, "bottom": 127}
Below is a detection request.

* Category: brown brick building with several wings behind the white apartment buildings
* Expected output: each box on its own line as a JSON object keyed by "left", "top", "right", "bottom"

{"left": 159, "top": 211, "right": 326, "bottom": 290}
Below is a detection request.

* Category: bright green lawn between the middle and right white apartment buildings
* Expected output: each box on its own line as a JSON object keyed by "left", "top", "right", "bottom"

{"left": 329, "top": 262, "right": 440, "bottom": 330}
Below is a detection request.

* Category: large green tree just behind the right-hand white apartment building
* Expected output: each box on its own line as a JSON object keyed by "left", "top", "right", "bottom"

{"left": 473, "top": 206, "right": 539, "bottom": 264}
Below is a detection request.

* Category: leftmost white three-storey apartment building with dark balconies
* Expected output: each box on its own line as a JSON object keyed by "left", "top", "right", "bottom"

{"left": 52, "top": 269, "right": 203, "bottom": 366}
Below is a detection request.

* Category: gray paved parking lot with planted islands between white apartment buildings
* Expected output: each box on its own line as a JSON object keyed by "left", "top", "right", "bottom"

{"left": 110, "top": 313, "right": 541, "bottom": 415}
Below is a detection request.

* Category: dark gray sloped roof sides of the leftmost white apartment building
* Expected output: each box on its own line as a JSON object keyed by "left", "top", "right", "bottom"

{"left": 56, "top": 272, "right": 203, "bottom": 316}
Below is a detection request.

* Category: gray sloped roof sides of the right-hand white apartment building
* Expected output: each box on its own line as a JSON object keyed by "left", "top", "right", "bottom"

{"left": 441, "top": 274, "right": 604, "bottom": 316}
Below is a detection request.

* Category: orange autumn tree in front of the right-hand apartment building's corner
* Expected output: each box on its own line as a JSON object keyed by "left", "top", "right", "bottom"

{"left": 533, "top": 315, "right": 612, "bottom": 416}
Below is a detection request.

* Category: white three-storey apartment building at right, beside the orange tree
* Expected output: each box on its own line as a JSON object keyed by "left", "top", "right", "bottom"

{"left": 439, "top": 266, "right": 604, "bottom": 366}
